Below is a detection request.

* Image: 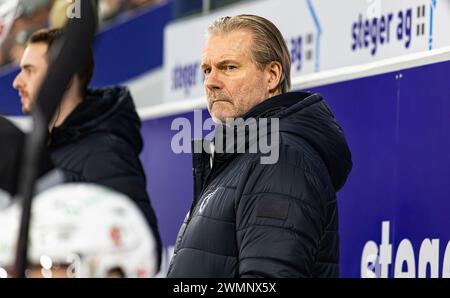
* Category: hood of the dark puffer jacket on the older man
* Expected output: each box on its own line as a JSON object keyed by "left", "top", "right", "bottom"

{"left": 244, "top": 92, "right": 352, "bottom": 191}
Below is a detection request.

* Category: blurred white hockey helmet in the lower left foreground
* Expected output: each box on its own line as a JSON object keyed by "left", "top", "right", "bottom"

{"left": 0, "top": 184, "right": 158, "bottom": 277}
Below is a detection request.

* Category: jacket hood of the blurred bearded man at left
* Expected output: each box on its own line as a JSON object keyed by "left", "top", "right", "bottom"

{"left": 49, "top": 87, "right": 143, "bottom": 154}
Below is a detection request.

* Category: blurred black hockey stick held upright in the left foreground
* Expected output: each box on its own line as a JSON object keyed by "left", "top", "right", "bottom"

{"left": 14, "top": 0, "right": 98, "bottom": 278}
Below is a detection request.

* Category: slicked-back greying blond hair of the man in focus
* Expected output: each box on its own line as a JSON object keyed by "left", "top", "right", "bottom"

{"left": 208, "top": 14, "right": 291, "bottom": 93}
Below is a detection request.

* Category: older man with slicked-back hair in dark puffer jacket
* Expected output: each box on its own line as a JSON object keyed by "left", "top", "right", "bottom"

{"left": 168, "top": 15, "right": 352, "bottom": 278}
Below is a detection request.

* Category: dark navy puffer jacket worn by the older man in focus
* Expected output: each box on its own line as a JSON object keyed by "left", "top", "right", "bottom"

{"left": 168, "top": 93, "right": 352, "bottom": 278}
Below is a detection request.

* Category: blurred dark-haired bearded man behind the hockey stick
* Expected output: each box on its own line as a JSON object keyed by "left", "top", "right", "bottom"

{"left": 13, "top": 29, "right": 162, "bottom": 266}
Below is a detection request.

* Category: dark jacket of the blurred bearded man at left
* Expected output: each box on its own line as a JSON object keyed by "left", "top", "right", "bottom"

{"left": 48, "top": 87, "right": 161, "bottom": 268}
